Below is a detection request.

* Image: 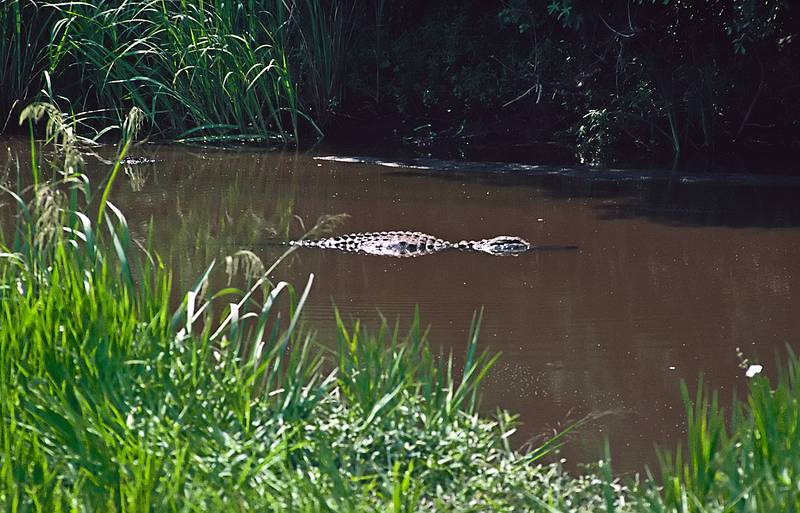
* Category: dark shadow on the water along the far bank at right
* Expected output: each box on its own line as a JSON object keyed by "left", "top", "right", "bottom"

{"left": 344, "top": 158, "right": 800, "bottom": 228}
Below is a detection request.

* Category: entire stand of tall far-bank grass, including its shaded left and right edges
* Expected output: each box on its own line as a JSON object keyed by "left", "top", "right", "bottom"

{"left": 0, "top": 0, "right": 354, "bottom": 145}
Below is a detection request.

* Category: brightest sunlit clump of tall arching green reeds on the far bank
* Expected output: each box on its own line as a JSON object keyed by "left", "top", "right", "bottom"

{"left": 46, "top": 1, "right": 310, "bottom": 142}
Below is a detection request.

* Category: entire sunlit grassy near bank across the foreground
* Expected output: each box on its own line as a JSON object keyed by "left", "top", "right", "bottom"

{"left": 0, "top": 110, "right": 800, "bottom": 512}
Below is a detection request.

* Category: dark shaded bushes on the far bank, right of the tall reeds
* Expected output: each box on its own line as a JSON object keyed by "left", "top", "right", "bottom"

{"left": 351, "top": 0, "right": 800, "bottom": 165}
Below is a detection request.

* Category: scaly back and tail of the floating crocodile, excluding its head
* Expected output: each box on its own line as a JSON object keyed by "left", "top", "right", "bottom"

{"left": 289, "top": 231, "right": 451, "bottom": 258}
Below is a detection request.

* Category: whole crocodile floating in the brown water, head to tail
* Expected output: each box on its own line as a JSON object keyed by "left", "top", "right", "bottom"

{"left": 289, "top": 231, "right": 531, "bottom": 258}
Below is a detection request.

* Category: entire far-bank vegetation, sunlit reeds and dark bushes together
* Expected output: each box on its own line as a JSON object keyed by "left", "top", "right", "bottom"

{"left": 0, "top": 0, "right": 800, "bottom": 169}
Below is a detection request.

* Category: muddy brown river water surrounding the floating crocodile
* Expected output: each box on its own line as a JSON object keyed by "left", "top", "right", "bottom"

{"left": 0, "top": 140, "right": 800, "bottom": 472}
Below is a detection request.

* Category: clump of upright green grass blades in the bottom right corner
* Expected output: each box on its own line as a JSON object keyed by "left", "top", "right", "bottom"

{"left": 648, "top": 349, "right": 800, "bottom": 512}
